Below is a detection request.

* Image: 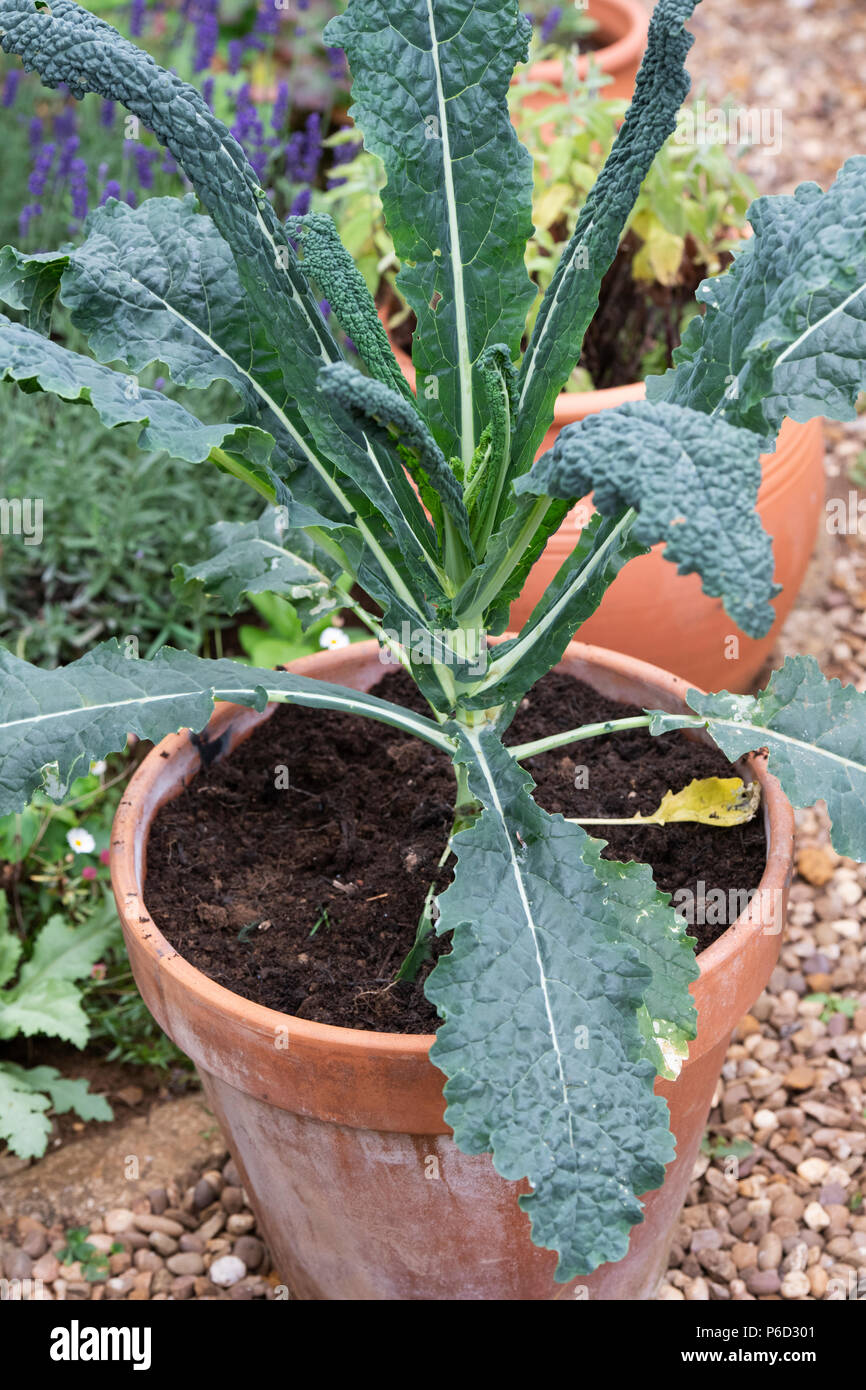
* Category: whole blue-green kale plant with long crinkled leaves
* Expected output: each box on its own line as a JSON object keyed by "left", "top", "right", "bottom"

{"left": 0, "top": 0, "right": 866, "bottom": 1282}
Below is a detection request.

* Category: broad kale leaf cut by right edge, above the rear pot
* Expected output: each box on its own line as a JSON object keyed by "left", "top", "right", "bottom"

{"left": 648, "top": 156, "right": 866, "bottom": 441}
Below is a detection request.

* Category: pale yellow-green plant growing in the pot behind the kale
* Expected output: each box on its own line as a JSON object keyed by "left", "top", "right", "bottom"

{"left": 322, "top": 79, "right": 755, "bottom": 391}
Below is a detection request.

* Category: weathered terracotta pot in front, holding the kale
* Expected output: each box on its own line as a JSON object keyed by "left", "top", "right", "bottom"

{"left": 111, "top": 642, "right": 794, "bottom": 1301}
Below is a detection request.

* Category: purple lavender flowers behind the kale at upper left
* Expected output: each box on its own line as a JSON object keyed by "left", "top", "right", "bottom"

{"left": 0, "top": 0, "right": 352, "bottom": 247}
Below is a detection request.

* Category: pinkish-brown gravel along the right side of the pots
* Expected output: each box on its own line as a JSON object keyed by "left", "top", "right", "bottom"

{"left": 657, "top": 0, "right": 866, "bottom": 1301}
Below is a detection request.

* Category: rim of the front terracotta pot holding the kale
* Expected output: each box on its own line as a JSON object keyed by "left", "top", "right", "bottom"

{"left": 110, "top": 639, "right": 794, "bottom": 1059}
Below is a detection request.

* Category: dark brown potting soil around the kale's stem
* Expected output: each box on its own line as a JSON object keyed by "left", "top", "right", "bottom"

{"left": 145, "top": 671, "right": 766, "bottom": 1033}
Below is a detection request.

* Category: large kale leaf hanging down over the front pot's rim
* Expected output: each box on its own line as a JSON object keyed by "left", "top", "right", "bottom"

{"left": 427, "top": 733, "right": 696, "bottom": 1282}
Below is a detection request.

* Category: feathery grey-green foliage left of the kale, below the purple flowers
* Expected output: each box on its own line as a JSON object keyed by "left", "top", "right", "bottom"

{"left": 0, "top": 380, "right": 261, "bottom": 666}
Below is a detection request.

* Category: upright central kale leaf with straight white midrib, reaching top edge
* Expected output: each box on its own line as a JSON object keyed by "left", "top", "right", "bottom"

{"left": 325, "top": 0, "right": 534, "bottom": 468}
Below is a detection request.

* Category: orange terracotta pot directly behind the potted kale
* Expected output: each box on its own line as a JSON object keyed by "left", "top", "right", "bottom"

{"left": 510, "top": 382, "right": 826, "bottom": 691}
